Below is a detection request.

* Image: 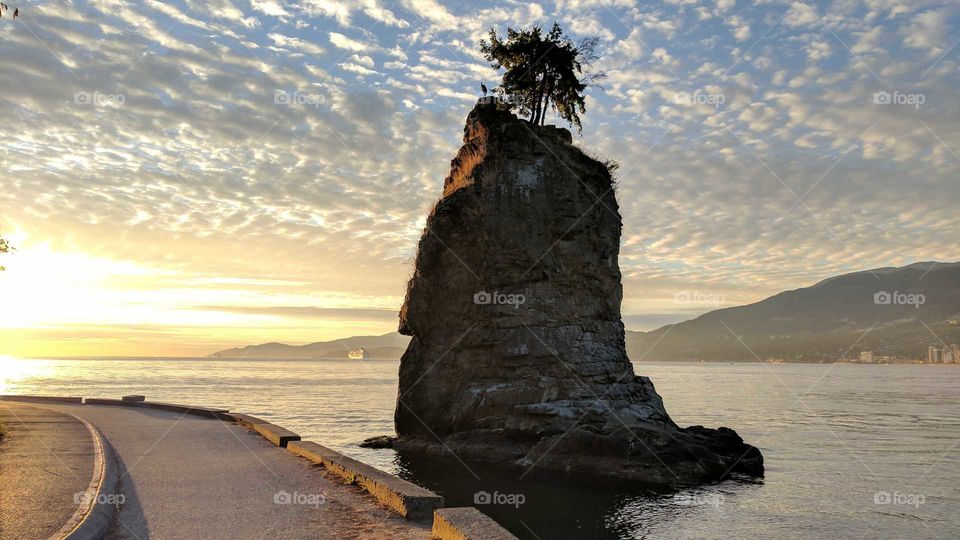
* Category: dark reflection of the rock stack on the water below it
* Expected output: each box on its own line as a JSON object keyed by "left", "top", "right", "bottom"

{"left": 395, "top": 451, "right": 762, "bottom": 539}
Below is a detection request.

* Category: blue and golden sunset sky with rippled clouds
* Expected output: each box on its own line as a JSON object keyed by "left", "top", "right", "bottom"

{"left": 0, "top": 0, "right": 960, "bottom": 356}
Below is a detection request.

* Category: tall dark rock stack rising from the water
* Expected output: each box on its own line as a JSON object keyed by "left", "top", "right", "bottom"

{"left": 395, "top": 105, "right": 763, "bottom": 484}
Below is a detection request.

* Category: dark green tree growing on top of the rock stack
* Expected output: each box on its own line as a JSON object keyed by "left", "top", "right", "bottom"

{"left": 480, "top": 23, "right": 606, "bottom": 131}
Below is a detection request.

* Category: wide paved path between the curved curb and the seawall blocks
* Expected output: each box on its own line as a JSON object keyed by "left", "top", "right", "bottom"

{"left": 42, "top": 404, "right": 430, "bottom": 540}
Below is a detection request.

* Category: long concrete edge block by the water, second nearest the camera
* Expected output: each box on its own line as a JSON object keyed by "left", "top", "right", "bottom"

{"left": 287, "top": 441, "right": 443, "bottom": 521}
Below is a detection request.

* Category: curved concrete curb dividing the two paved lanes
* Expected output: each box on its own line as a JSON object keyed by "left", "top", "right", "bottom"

{"left": 51, "top": 415, "right": 122, "bottom": 540}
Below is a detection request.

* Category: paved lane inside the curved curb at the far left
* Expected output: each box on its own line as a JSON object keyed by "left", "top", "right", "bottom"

{"left": 0, "top": 401, "right": 94, "bottom": 540}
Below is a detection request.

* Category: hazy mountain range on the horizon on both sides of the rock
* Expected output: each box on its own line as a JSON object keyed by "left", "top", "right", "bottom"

{"left": 210, "top": 262, "right": 960, "bottom": 362}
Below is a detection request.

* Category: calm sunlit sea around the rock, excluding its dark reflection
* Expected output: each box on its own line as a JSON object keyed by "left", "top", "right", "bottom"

{"left": 0, "top": 358, "right": 960, "bottom": 539}
